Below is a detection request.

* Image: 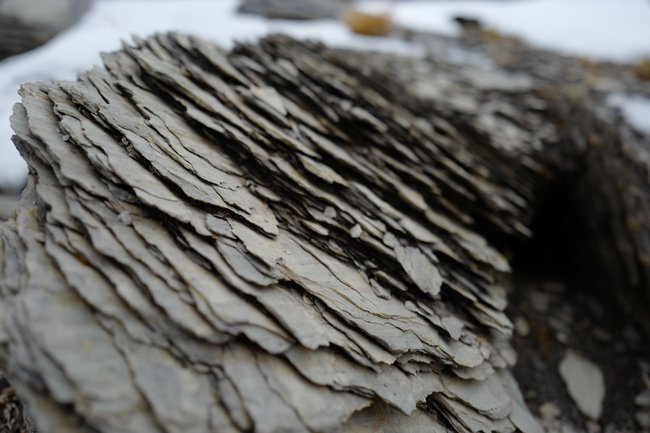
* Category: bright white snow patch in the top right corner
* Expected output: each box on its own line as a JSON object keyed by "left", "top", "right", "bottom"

{"left": 393, "top": 0, "right": 650, "bottom": 61}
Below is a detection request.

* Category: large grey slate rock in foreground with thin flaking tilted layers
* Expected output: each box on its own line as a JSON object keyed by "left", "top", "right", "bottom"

{"left": 0, "top": 34, "right": 541, "bottom": 433}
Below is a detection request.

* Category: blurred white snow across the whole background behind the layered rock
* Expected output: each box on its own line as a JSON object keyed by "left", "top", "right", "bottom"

{"left": 0, "top": 0, "right": 650, "bottom": 185}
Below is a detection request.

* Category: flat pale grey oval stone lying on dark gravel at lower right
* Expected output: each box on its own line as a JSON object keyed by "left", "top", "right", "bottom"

{"left": 559, "top": 350, "right": 605, "bottom": 421}
